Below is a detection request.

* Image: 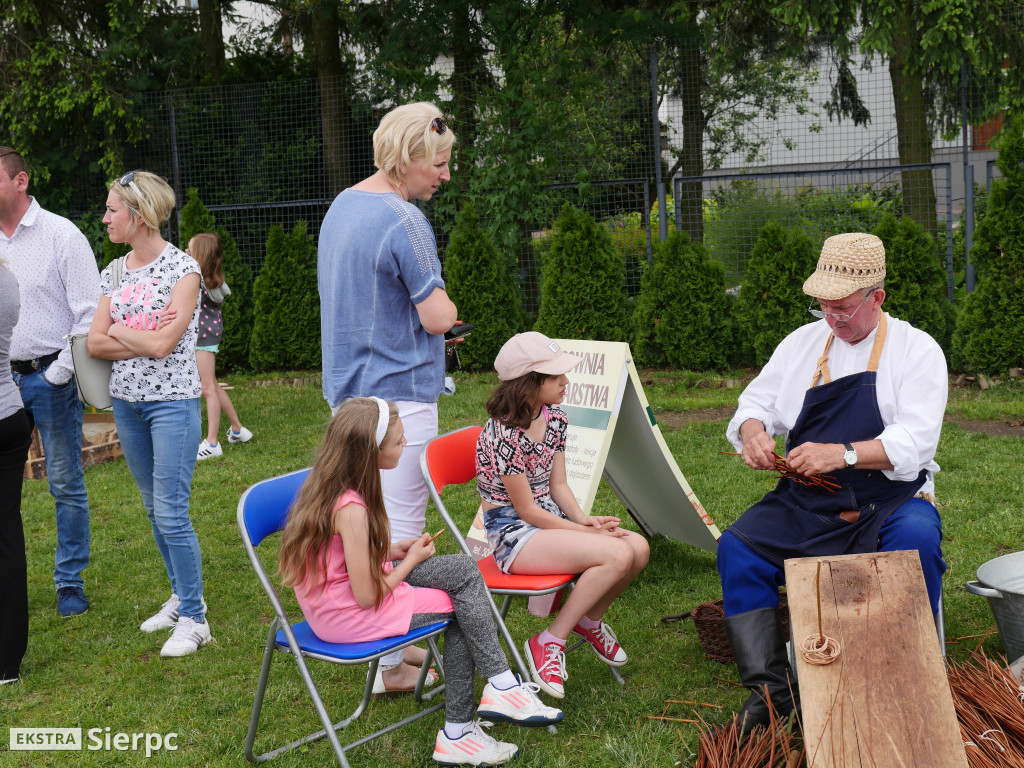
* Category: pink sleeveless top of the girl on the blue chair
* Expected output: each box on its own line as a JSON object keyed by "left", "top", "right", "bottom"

{"left": 295, "top": 490, "right": 415, "bottom": 643}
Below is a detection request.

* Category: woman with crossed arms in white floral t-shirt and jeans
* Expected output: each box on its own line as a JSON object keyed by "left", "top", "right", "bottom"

{"left": 88, "top": 171, "right": 212, "bottom": 656}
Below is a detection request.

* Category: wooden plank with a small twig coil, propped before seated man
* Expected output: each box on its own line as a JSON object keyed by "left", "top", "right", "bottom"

{"left": 785, "top": 551, "right": 968, "bottom": 768}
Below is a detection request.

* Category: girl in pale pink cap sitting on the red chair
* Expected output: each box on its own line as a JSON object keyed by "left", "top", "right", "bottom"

{"left": 476, "top": 332, "right": 650, "bottom": 698}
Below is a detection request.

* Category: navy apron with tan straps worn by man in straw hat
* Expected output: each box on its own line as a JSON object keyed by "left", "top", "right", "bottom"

{"left": 729, "top": 313, "right": 927, "bottom": 566}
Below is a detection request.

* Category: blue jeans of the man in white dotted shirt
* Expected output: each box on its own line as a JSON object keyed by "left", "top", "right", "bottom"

{"left": 13, "top": 371, "right": 89, "bottom": 589}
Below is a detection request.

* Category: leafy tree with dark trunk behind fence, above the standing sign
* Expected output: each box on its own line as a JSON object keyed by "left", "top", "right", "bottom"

{"left": 561, "top": 0, "right": 819, "bottom": 242}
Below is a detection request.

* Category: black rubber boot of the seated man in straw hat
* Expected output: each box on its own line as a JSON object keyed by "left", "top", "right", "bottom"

{"left": 725, "top": 608, "right": 799, "bottom": 733}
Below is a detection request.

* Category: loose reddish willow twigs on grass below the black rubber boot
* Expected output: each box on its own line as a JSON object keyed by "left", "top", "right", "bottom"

{"left": 682, "top": 701, "right": 804, "bottom": 768}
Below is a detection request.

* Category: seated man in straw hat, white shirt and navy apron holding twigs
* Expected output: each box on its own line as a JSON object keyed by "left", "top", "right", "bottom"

{"left": 718, "top": 232, "right": 947, "bottom": 731}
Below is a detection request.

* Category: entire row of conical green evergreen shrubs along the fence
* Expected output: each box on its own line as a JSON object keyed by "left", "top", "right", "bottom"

{"left": 180, "top": 107, "right": 1024, "bottom": 374}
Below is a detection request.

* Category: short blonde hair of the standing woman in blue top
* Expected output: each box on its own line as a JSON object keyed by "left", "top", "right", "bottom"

{"left": 374, "top": 101, "right": 455, "bottom": 186}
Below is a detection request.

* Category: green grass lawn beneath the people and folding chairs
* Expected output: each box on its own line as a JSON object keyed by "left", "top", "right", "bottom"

{"left": 0, "top": 372, "right": 1024, "bottom": 768}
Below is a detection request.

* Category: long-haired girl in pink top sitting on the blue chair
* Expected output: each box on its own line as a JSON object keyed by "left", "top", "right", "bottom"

{"left": 279, "top": 397, "right": 562, "bottom": 765}
